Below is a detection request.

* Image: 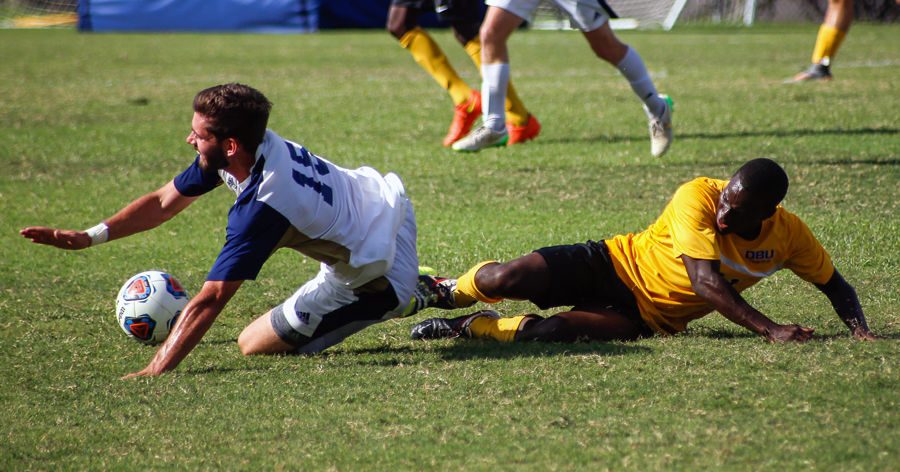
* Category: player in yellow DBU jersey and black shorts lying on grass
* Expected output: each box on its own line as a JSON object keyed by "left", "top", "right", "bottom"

{"left": 412, "top": 159, "right": 876, "bottom": 342}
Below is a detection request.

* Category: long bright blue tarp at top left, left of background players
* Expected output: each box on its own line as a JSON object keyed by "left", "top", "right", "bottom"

{"left": 78, "top": 0, "right": 322, "bottom": 33}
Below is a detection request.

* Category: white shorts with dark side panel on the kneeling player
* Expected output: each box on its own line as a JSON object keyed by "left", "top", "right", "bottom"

{"left": 271, "top": 202, "right": 419, "bottom": 353}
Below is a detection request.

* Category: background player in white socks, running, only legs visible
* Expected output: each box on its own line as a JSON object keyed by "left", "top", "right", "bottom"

{"left": 453, "top": 0, "right": 672, "bottom": 156}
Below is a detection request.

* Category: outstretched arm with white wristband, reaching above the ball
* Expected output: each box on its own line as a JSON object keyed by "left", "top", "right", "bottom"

{"left": 19, "top": 181, "right": 197, "bottom": 250}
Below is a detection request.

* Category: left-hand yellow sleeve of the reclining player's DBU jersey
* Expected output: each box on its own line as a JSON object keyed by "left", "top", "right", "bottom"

{"left": 663, "top": 178, "right": 721, "bottom": 260}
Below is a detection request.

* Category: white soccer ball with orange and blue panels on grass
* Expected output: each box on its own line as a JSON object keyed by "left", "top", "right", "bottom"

{"left": 116, "top": 270, "right": 191, "bottom": 344}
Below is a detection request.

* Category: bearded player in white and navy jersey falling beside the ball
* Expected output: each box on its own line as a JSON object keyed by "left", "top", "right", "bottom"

{"left": 21, "top": 84, "right": 436, "bottom": 378}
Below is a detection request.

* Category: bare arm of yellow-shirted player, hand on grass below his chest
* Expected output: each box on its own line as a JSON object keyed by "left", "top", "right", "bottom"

{"left": 681, "top": 255, "right": 813, "bottom": 342}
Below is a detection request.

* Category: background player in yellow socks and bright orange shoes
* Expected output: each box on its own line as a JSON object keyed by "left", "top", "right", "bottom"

{"left": 387, "top": 0, "right": 541, "bottom": 146}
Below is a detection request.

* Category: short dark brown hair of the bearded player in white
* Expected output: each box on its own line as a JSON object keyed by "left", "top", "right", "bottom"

{"left": 194, "top": 83, "right": 272, "bottom": 152}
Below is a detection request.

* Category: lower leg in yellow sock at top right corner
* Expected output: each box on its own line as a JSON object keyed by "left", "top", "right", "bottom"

{"left": 785, "top": 0, "right": 856, "bottom": 84}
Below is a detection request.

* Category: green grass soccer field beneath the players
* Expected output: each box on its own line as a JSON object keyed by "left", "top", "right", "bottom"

{"left": 0, "top": 24, "right": 900, "bottom": 471}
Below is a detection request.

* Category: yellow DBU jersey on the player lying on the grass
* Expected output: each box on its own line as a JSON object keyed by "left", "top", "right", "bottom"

{"left": 606, "top": 177, "right": 834, "bottom": 334}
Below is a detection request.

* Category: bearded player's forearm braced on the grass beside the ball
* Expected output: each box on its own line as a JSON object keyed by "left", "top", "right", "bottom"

{"left": 122, "top": 280, "right": 244, "bottom": 380}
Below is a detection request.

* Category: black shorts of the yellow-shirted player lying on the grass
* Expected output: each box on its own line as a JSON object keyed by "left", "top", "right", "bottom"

{"left": 530, "top": 241, "right": 653, "bottom": 336}
